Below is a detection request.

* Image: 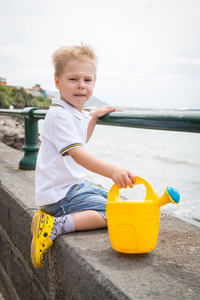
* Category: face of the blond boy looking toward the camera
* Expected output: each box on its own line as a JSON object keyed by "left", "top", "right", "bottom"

{"left": 54, "top": 60, "right": 95, "bottom": 112}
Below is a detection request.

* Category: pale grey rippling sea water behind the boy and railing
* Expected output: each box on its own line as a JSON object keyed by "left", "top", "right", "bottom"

{"left": 39, "top": 110, "right": 200, "bottom": 227}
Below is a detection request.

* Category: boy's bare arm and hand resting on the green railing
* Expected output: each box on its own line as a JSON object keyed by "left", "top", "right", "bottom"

{"left": 87, "top": 106, "right": 115, "bottom": 142}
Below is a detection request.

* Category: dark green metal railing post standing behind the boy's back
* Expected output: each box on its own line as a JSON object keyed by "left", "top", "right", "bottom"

{"left": 19, "top": 107, "right": 39, "bottom": 170}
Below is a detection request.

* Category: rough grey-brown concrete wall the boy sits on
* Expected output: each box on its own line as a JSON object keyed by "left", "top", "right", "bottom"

{"left": 0, "top": 143, "right": 200, "bottom": 300}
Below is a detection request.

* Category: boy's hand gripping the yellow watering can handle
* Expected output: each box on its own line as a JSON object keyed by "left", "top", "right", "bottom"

{"left": 111, "top": 168, "right": 136, "bottom": 189}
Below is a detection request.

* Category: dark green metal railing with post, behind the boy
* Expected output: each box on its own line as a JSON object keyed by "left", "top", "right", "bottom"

{"left": 0, "top": 107, "right": 200, "bottom": 170}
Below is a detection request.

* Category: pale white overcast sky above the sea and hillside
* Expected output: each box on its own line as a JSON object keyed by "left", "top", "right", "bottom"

{"left": 0, "top": 0, "right": 200, "bottom": 108}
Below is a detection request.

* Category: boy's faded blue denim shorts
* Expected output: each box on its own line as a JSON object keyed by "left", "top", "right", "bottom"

{"left": 41, "top": 182, "right": 108, "bottom": 220}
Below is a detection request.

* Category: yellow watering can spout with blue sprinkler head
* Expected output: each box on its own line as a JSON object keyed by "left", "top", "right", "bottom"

{"left": 157, "top": 186, "right": 180, "bottom": 207}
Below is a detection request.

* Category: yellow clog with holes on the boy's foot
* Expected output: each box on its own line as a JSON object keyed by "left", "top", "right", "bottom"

{"left": 31, "top": 210, "right": 54, "bottom": 269}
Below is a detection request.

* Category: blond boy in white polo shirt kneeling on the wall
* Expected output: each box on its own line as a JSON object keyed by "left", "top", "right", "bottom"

{"left": 31, "top": 44, "right": 135, "bottom": 269}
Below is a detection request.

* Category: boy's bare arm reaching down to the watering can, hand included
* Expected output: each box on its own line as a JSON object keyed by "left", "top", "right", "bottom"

{"left": 68, "top": 147, "right": 136, "bottom": 188}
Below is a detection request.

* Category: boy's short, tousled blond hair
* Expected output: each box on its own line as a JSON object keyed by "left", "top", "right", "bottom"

{"left": 52, "top": 43, "right": 97, "bottom": 79}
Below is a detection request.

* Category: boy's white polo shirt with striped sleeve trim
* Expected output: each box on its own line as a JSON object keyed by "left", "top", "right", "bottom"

{"left": 35, "top": 98, "right": 91, "bottom": 206}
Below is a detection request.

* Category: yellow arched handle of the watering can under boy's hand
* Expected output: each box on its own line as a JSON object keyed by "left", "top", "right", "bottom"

{"left": 107, "top": 176, "right": 158, "bottom": 201}
